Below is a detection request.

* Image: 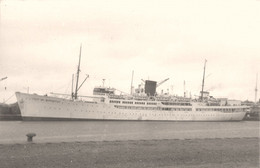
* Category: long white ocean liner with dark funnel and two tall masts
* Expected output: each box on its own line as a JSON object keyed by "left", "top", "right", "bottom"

{"left": 16, "top": 48, "right": 248, "bottom": 121}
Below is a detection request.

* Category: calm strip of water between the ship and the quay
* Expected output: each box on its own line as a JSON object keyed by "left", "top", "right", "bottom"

{"left": 0, "top": 121, "right": 260, "bottom": 144}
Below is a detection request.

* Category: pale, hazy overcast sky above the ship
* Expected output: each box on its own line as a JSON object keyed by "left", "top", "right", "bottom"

{"left": 0, "top": 0, "right": 260, "bottom": 103}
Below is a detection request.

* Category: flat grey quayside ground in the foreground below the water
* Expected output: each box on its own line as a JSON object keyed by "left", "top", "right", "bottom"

{"left": 0, "top": 137, "right": 260, "bottom": 168}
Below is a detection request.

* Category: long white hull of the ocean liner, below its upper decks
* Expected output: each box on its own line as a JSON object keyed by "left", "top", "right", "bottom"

{"left": 16, "top": 92, "right": 246, "bottom": 121}
